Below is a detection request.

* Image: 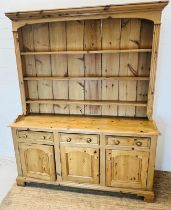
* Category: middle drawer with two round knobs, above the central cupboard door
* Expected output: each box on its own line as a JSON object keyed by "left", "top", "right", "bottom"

{"left": 60, "top": 133, "right": 99, "bottom": 144}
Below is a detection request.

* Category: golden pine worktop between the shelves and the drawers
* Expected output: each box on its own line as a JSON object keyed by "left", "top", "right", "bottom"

{"left": 10, "top": 115, "right": 159, "bottom": 136}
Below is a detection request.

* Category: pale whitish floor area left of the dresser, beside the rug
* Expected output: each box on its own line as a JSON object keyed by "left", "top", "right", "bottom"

{"left": 0, "top": 157, "right": 17, "bottom": 203}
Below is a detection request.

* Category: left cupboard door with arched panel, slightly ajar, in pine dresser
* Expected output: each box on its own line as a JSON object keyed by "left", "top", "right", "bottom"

{"left": 19, "top": 143, "right": 56, "bottom": 181}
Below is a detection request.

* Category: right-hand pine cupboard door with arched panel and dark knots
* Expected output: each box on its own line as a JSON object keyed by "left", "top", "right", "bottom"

{"left": 106, "top": 149, "right": 149, "bottom": 189}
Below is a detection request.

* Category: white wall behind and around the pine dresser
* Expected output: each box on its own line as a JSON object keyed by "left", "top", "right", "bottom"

{"left": 0, "top": 0, "right": 171, "bottom": 171}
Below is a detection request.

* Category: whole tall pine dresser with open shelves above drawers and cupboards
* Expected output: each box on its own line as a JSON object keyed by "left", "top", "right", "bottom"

{"left": 6, "top": 1, "right": 168, "bottom": 201}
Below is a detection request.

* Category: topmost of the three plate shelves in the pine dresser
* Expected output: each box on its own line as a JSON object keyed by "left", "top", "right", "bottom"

{"left": 20, "top": 49, "right": 152, "bottom": 55}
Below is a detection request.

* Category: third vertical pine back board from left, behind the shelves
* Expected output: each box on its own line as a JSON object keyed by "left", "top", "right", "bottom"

{"left": 49, "top": 20, "right": 69, "bottom": 114}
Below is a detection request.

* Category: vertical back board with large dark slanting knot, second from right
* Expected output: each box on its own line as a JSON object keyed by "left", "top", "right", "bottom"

{"left": 118, "top": 19, "right": 141, "bottom": 117}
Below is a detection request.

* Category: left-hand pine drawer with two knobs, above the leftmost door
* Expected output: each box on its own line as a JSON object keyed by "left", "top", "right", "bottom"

{"left": 17, "top": 131, "right": 53, "bottom": 141}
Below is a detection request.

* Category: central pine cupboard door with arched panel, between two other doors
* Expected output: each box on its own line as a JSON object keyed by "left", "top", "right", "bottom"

{"left": 61, "top": 145, "right": 99, "bottom": 184}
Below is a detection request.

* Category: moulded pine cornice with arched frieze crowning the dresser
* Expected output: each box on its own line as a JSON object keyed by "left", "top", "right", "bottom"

{"left": 6, "top": 0, "right": 168, "bottom": 25}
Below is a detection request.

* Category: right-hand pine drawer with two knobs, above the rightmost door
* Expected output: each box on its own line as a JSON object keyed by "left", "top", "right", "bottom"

{"left": 107, "top": 136, "right": 150, "bottom": 147}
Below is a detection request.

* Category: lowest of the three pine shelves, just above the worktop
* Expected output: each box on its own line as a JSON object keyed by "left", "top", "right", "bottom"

{"left": 26, "top": 99, "right": 147, "bottom": 107}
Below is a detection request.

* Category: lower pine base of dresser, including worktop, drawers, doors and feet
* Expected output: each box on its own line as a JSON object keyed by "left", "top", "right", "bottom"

{"left": 12, "top": 120, "right": 157, "bottom": 202}
